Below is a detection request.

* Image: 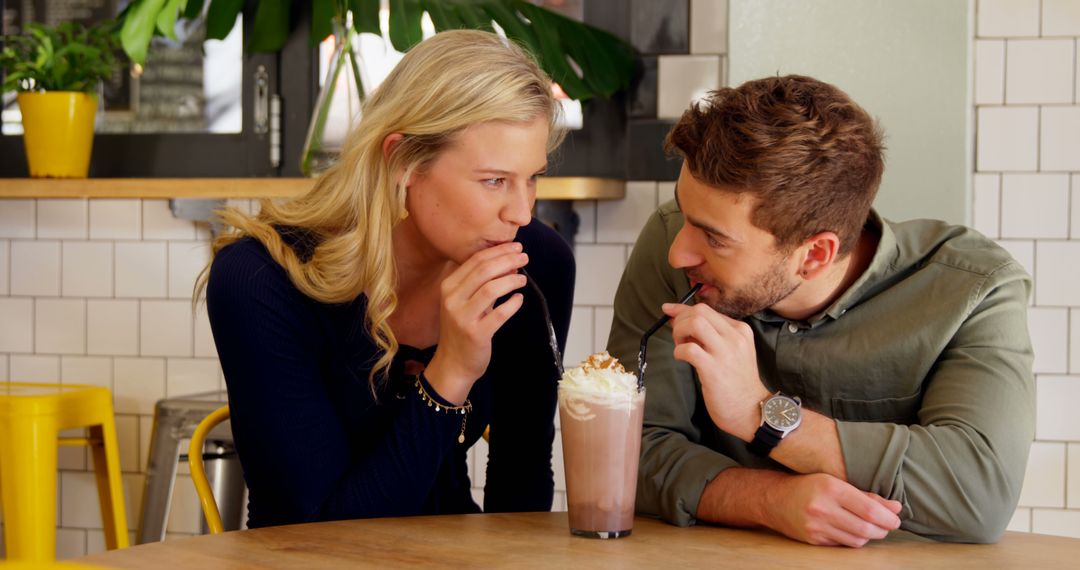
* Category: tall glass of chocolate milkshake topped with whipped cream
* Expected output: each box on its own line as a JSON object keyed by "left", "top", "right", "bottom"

{"left": 558, "top": 352, "right": 645, "bottom": 539}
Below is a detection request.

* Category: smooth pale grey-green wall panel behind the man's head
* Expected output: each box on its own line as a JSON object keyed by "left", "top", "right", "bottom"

{"left": 729, "top": 0, "right": 973, "bottom": 223}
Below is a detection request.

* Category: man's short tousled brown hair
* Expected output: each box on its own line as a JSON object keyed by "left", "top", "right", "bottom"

{"left": 665, "top": 76, "right": 885, "bottom": 255}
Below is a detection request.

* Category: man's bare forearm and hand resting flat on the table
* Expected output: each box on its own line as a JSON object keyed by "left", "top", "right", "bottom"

{"left": 698, "top": 467, "right": 902, "bottom": 547}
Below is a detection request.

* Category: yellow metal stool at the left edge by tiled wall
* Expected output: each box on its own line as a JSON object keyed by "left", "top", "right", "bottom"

{"left": 0, "top": 382, "right": 127, "bottom": 560}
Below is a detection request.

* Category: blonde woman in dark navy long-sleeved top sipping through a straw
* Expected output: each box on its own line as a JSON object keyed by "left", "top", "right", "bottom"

{"left": 206, "top": 30, "right": 575, "bottom": 527}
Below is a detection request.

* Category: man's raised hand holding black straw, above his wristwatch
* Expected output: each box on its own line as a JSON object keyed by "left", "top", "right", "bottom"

{"left": 663, "top": 303, "right": 769, "bottom": 442}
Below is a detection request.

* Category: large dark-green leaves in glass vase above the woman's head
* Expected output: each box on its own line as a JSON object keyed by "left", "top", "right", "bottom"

{"left": 120, "top": 0, "right": 637, "bottom": 175}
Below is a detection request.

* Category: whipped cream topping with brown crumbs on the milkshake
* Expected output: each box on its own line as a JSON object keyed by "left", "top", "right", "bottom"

{"left": 558, "top": 351, "right": 645, "bottom": 420}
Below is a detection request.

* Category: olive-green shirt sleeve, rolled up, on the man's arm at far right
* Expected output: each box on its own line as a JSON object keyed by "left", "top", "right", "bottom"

{"left": 837, "top": 263, "right": 1035, "bottom": 542}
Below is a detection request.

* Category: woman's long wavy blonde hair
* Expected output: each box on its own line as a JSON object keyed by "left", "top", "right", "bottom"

{"left": 195, "top": 30, "right": 563, "bottom": 393}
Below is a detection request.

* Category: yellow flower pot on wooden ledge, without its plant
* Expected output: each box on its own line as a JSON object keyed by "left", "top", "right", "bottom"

{"left": 18, "top": 91, "right": 97, "bottom": 178}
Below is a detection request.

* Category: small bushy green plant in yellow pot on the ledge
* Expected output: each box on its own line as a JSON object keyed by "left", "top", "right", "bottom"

{"left": 0, "top": 22, "right": 119, "bottom": 178}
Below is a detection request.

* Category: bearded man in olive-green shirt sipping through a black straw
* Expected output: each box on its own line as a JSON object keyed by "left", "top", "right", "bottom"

{"left": 608, "top": 76, "right": 1035, "bottom": 546}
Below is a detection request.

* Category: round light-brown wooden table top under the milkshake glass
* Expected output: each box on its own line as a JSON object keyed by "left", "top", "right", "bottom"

{"left": 73, "top": 513, "right": 1080, "bottom": 570}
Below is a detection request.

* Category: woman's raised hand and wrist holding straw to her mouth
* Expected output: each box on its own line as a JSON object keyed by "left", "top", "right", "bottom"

{"left": 424, "top": 242, "right": 529, "bottom": 405}
